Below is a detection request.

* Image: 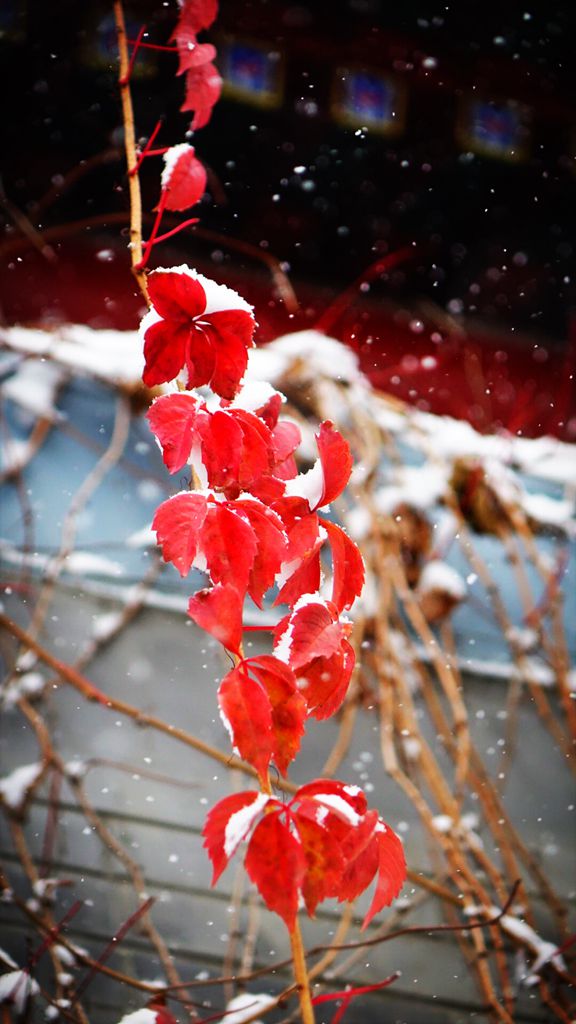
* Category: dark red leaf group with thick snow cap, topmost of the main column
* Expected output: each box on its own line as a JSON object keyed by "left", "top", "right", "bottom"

{"left": 140, "top": 266, "right": 255, "bottom": 398}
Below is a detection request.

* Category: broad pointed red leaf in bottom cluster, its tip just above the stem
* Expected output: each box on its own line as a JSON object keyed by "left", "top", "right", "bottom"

{"left": 245, "top": 813, "right": 305, "bottom": 931}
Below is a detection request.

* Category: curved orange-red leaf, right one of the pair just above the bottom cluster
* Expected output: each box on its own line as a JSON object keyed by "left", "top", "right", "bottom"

{"left": 244, "top": 654, "right": 307, "bottom": 775}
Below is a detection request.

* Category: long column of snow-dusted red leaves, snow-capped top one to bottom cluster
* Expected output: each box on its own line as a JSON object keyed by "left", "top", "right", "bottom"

{"left": 142, "top": 258, "right": 405, "bottom": 929}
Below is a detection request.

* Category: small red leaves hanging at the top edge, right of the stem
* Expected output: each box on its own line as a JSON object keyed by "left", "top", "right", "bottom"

{"left": 171, "top": 0, "right": 222, "bottom": 131}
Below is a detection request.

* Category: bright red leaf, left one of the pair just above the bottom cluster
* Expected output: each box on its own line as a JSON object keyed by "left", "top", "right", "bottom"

{"left": 218, "top": 665, "right": 275, "bottom": 780}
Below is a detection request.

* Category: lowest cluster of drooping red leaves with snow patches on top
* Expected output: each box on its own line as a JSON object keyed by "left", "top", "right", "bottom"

{"left": 203, "top": 779, "right": 406, "bottom": 930}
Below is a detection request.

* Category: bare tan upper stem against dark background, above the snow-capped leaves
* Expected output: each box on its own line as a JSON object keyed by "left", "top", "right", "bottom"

{"left": 114, "top": 0, "right": 150, "bottom": 305}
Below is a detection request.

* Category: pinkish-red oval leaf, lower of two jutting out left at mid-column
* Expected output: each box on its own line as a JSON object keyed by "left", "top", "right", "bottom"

{"left": 152, "top": 490, "right": 208, "bottom": 577}
